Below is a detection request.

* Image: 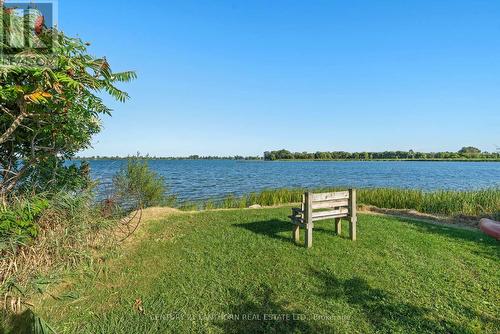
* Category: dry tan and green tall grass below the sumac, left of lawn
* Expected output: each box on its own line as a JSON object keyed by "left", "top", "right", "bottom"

{"left": 0, "top": 190, "right": 125, "bottom": 333}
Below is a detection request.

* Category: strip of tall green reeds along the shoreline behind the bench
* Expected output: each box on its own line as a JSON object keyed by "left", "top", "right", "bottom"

{"left": 189, "top": 187, "right": 500, "bottom": 218}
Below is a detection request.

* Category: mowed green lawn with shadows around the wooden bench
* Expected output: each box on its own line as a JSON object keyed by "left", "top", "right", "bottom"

{"left": 35, "top": 208, "right": 500, "bottom": 333}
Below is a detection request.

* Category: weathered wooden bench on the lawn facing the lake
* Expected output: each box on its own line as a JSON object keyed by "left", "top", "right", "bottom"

{"left": 289, "top": 189, "right": 357, "bottom": 248}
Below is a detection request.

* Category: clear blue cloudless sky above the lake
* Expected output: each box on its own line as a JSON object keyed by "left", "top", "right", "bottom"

{"left": 59, "top": 0, "right": 500, "bottom": 156}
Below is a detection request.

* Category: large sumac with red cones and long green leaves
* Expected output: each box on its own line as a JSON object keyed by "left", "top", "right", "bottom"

{"left": 0, "top": 6, "right": 136, "bottom": 198}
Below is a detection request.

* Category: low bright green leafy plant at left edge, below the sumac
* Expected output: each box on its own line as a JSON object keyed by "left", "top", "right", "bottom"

{"left": 0, "top": 197, "right": 49, "bottom": 239}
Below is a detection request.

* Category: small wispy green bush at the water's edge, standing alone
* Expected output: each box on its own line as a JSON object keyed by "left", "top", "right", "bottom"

{"left": 113, "top": 158, "right": 167, "bottom": 207}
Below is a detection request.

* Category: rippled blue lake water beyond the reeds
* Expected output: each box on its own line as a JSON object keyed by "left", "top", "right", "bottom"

{"left": 79, "top": 160, "right": 500, "bottom": 201}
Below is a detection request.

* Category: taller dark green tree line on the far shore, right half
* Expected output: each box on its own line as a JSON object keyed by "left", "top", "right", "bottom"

{"left": 264, "top": 146, "right": 500, "bottom": 161}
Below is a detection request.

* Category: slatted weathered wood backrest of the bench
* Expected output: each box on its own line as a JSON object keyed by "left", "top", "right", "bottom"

{"left": 302, "top": 189, "right": 356, "bottom": 221}
